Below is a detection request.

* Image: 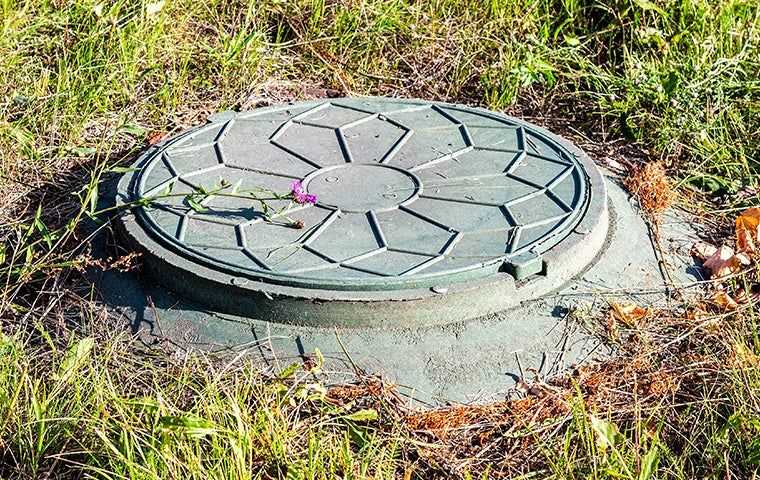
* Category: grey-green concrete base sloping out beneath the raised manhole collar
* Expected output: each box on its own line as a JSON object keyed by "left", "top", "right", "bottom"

{"left": 98, "top": 173, "right": 699, "bottom": 404}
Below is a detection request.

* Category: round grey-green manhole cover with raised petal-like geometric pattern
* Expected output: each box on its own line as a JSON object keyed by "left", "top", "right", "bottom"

{"left": 119, "top": 98, "right": 606, "bottom": 326}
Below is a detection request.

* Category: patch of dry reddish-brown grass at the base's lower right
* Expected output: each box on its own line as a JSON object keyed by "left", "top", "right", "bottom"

{"left": 382, "top": 301, "right": 760, "bottom": 478}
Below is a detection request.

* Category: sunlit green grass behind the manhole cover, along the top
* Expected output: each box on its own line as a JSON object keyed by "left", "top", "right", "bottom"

{"left": 0, "top": 0, "right": 760, "bottom": 191}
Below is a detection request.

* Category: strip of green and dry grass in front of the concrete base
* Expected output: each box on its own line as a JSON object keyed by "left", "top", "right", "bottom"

{"left": 0, "top": 298, "right": 760, "bottom": 480}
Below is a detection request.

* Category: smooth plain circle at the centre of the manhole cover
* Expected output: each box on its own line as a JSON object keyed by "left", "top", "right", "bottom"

{"left": 304, "top": 163, "right": 422, "bottom": 213}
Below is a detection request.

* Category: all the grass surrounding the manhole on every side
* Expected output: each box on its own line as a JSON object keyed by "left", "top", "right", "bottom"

{"left": 0, "top": 0, "right": 760, "bottom": 480}
